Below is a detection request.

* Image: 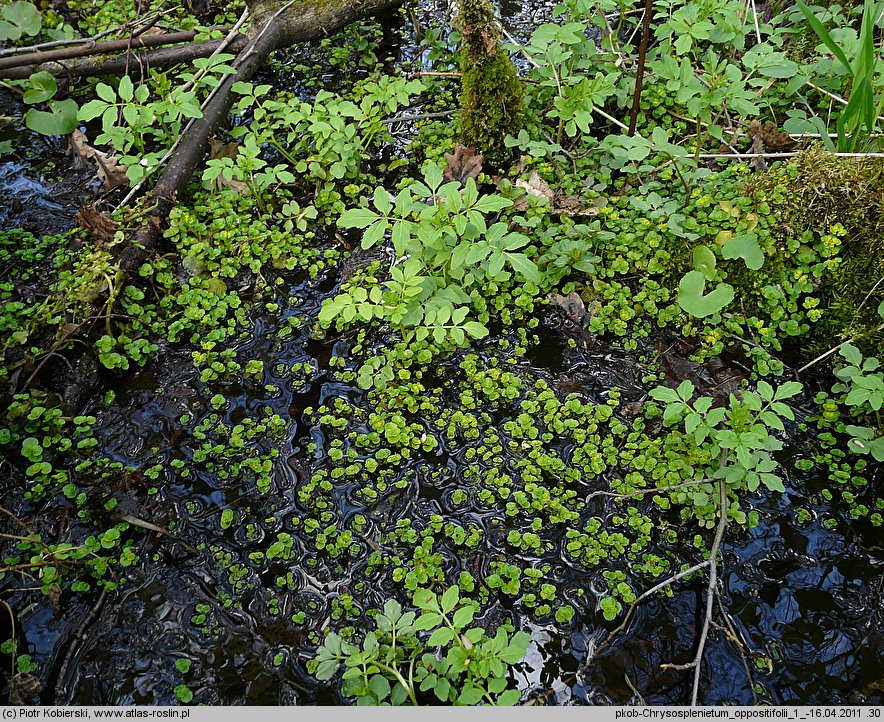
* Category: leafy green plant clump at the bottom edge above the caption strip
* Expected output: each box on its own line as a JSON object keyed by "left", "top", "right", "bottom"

{"left": 308, "top": 586, "right": 531, "bottom": 705}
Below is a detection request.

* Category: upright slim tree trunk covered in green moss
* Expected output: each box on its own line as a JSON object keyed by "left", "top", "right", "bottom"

{"left": 457, "top": 0, "right": 525, "bottom": 169}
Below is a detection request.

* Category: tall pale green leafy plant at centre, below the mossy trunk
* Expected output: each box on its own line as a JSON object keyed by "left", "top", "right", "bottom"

{"left": 319, "top": 164, "right": 541, "bottom": 382}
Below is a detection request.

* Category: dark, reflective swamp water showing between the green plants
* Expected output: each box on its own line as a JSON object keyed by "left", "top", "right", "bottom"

{"left": 0, "top": 4, "right": 884, "bottom": 705}
